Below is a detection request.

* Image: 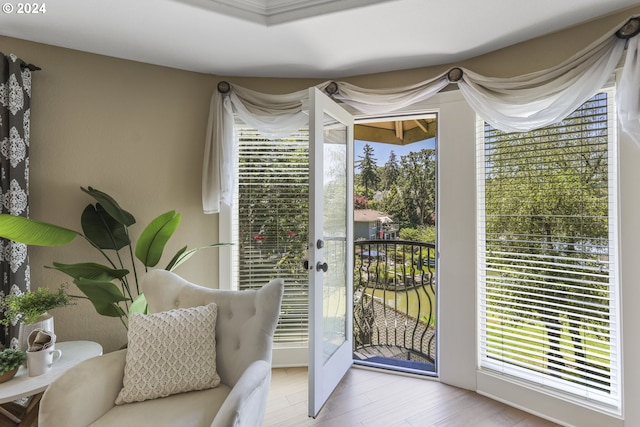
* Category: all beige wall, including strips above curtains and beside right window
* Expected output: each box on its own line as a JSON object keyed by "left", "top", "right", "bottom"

{"left": 0, "top": 3, "right": 640, "bottom": 426}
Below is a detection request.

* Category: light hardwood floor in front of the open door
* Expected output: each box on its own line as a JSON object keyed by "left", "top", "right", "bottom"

{"left": 263, "top": 368, "right": 557, "bottom": 427}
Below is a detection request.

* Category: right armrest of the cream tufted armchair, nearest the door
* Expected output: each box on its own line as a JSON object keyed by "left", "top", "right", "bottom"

{"left": 211, "top": 360, "right": 271, "bottom": 427}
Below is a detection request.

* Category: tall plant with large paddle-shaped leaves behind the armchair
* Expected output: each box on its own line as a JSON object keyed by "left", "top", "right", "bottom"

{"left": 0, "top": 187, "right": 227, "bottom": 328}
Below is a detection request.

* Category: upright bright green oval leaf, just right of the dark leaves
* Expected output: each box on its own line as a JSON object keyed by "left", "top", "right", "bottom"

{"left": 136, "top": 211, "right": 180, "bottom": 267}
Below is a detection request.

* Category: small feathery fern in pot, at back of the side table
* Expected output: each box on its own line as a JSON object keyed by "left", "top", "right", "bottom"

{"left": 0, "top": 285, "right": 73, "bottom": 350}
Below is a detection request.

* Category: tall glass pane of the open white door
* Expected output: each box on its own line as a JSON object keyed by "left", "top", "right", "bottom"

{"left": 322, "top": 114, "right": 348, "bottom": 362}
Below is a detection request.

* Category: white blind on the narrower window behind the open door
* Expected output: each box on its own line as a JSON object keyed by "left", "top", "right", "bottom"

{"left": 232, "top": 126, "right": 309, "bottom": 343}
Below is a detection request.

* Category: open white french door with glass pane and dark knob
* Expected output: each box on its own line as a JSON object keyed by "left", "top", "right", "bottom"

{"left": 308, "top": 88, "right": 353, "bottom": 418}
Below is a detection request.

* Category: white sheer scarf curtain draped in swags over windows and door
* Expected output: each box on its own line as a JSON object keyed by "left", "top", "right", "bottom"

{"left": 202, "top": 17, "right": 640, "bottom": 213}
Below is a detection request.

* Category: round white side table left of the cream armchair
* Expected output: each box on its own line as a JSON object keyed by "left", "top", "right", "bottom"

{"left": 0, "top": 341, "right": 102, "bottom": 425}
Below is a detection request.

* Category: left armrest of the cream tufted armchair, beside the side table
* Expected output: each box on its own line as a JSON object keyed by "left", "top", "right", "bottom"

{"left": 38, "top": 350, "right": 127, "bottom": 427}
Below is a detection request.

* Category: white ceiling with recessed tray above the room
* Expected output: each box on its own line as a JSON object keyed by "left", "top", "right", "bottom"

{"left": 0, "top": 0, "right": 640, "bottom": 78}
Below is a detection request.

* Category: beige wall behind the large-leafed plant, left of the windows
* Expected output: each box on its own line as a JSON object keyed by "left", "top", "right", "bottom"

{"left": 0, "top": 38, "right": 228, "bottom": 351}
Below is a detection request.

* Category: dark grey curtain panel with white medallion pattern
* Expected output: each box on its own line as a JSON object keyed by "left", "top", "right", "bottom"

{"left": 0, "top": 53, "right": 31, "bottom": 346}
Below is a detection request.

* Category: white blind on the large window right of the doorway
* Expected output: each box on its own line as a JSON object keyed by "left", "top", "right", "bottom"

{"left": 477, "top": 91, "right": 620, "bottom": 408}
